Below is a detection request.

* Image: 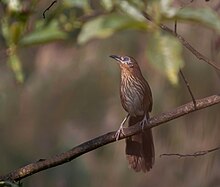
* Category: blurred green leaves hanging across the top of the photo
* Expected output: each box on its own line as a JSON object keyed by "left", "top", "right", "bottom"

{"left": 1, "top": 0, "right": 220, "bottom": 84}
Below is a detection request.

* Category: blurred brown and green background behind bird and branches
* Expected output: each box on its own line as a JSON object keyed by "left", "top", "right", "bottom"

{"left": 0, "top": 0, "right": 220, "bottom": 187}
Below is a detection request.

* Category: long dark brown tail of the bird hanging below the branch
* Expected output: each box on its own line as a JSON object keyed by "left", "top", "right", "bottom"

{"left": 125, "top": 116, "right": 155, "bottom": 172}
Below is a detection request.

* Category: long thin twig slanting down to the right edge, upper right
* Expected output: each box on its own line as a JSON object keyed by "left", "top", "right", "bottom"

{"left": 143, "top": 12, "right": 220, "bottom": 71}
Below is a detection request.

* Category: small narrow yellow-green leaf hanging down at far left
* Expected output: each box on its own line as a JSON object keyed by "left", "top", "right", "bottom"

{"left": 8, "top": 52, "right": 24, "bottom": 83}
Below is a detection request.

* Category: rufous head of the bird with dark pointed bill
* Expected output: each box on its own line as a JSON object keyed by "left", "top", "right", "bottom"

{"left": 110, "top": 55, "right": 138, "bottom": 70}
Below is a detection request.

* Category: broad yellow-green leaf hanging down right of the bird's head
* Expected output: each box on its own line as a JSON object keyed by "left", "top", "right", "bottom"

{"left": 147, "top": 32, "right": 184, "bottom": 85}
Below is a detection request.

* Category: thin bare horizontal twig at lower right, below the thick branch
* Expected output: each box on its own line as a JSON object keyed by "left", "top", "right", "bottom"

{"left": 160, "top": 147, "right": 220, "bottom": 158}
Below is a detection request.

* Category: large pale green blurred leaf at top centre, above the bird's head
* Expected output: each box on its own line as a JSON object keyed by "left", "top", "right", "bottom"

{"left": 78, "top": 14, "right": 147, "bottom": 44}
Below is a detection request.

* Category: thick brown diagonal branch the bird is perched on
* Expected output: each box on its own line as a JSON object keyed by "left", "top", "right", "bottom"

{"left": 0, "top": 94, "right": 220, "bottom": 181}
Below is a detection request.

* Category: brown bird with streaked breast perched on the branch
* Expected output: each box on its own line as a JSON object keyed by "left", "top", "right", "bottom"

{"left": 110, "top": 55, "right": 155, "bottom": 173}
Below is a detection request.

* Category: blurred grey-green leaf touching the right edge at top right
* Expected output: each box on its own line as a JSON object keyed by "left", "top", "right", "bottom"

{"left": 175, "top": 8, "right": 220, "bottom": 32}
